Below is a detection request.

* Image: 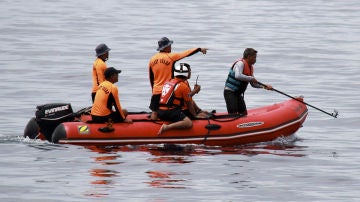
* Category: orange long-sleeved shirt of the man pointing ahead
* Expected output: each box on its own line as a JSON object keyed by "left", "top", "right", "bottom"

{"left": 149, "top": 48, "right": 201, "bottom": 95}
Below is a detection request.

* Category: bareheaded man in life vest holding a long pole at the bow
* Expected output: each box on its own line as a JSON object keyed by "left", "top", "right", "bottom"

{"left": 224, "top": 48, "right": 272, "bottom": 115}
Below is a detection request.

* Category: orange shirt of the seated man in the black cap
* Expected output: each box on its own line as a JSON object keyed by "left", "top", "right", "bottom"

{"left": 91, "top": 80, "right": 125, "bottom": 119}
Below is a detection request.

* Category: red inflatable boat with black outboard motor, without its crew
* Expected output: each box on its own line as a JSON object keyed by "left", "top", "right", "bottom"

{"left": 24, "top": 97, "right": 308, "bottom": 146}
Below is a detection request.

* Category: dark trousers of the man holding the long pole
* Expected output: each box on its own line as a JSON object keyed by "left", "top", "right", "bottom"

{"left": 224, "top": 90, "right": 247, "bottom": 115}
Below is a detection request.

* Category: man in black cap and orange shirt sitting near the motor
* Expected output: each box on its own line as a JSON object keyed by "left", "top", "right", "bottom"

{"left": 91, "top": 67, "right": 132, "bottom": 123}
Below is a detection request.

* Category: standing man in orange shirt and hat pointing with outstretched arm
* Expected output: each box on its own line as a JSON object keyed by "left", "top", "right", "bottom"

{"left": 149, "top": 37, "right": 207, "bottom": 120}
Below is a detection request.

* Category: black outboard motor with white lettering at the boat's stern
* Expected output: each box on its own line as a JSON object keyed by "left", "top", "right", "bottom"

{"left": 35, "top": 103, "right": 74, "bottom": 141}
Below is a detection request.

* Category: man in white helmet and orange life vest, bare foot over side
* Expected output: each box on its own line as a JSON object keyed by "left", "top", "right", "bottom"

{"left": 158, "top": 63, "right": 209, "bottom": 135}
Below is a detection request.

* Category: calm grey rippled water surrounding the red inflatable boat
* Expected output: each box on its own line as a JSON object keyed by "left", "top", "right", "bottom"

{"left": 0, "top": 0, "right": 360, "bottom": 201}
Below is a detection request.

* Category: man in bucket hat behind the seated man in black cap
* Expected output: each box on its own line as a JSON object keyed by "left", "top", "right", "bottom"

{"left": 91, "top": 43, "right": 111, "bottom": 103}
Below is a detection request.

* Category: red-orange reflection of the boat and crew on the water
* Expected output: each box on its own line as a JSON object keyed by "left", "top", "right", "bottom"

{"left": 82, "top": 137, "right": 306, "bottom": 191}
